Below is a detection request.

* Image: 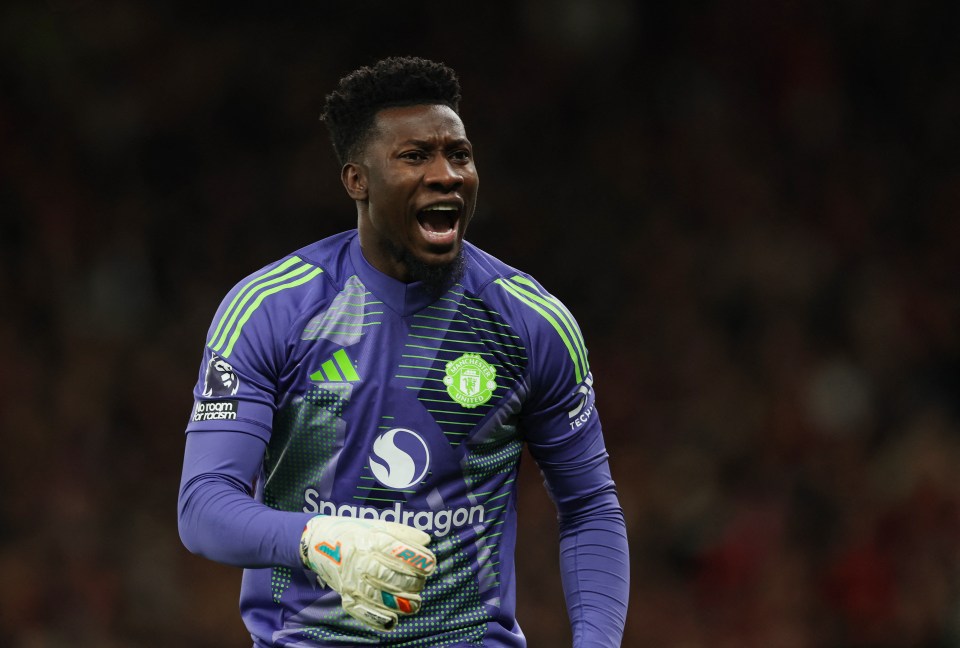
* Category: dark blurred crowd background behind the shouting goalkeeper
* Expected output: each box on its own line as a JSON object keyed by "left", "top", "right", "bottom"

{"left": 0, "top": 0, "right": 960, "bottom": 648}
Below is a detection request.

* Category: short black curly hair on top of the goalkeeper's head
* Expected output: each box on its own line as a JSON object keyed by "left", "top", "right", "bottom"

{"left": 320, "top": 56, "right": 460, "bottom": 165}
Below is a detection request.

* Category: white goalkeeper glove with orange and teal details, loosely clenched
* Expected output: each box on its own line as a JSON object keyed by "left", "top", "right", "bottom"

{"left": 300, "top": 515, "right": 437, "bottom": 630}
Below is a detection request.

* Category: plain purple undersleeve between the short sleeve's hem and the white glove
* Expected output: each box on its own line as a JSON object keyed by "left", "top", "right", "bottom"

{"left": 178, "top": 431, "right": 312, "bottom": 568}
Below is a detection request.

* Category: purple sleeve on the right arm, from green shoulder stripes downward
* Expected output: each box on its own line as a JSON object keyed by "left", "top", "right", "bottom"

{"left": 499, "top": 275, "right": 630, "bottom": 648}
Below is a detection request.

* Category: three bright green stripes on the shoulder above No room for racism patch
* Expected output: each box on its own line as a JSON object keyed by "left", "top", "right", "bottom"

{"left": 207, "top": 257, "right": 323, "bottom": 358}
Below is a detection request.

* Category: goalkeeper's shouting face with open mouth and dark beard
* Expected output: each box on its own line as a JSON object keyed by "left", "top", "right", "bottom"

{"left": 345, "top": 105, "right": 479, "bottom": 281}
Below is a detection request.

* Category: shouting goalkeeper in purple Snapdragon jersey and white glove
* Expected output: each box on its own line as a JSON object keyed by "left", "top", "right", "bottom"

{"left": 179, "top": 58, "right": 629, "bottom": 648}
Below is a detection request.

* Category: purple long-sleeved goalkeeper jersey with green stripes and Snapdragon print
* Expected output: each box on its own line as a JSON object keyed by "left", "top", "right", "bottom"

{"left": 180, "top": 231, "right": 628, "bottom": 647}
